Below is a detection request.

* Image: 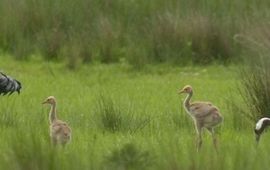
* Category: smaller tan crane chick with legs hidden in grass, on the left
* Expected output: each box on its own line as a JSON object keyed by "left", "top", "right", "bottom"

{"left": 42, "top": 96, "right": 71, "bottom": 145}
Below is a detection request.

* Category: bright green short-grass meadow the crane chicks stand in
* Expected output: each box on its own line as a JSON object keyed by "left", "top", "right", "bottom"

{"left": 0, "top": 56, "right": 270, "bottom": 170}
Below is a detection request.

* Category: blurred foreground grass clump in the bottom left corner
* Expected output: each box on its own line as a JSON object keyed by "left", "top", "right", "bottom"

{"left": 0, "top": 127, "right": 89, "bottom": 170}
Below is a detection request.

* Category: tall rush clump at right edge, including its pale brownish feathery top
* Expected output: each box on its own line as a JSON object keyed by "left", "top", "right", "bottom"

{"left": 234, "top": 23, "right": 270, "bottom": 121}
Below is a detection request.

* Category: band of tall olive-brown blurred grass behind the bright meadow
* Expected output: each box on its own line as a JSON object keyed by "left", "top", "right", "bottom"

{"left": 0, "top": 0, "right": 269, "bottom": 69}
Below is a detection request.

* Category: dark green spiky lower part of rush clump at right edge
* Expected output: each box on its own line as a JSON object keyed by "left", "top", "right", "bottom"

{"left": 240, "top": 59, "right": 270, "bottom": 121}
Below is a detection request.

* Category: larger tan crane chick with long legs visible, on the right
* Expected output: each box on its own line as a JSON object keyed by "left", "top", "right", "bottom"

{"left": 179, "top": 85, "right": 223, "bottom": 151}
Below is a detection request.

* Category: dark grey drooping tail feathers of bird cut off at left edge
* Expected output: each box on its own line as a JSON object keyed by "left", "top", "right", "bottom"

{"left": 0, "top": 72, "right": 22, "bottom": 96}
